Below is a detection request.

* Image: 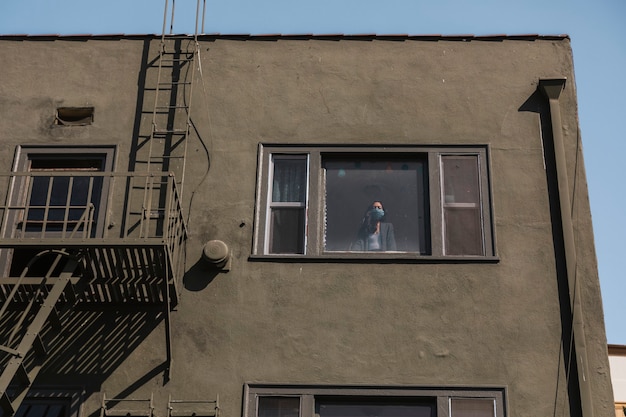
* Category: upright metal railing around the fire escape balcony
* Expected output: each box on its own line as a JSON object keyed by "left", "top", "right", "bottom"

{"left": 0, "top": 171, "right": 185, "bottom": 247}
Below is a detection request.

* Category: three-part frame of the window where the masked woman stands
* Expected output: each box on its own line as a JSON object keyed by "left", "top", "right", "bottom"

{"left": 251, "top": 144, "right": 498, "bottom": 262}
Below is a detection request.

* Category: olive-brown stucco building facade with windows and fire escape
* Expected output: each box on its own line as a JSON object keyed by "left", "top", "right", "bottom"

{"left": 0, "top": 30, "right": 613, "bottom": 417}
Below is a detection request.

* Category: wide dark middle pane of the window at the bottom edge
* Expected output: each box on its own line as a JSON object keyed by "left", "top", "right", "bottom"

{"left": 319, "top": 401, "right": 435, "bottom": 417}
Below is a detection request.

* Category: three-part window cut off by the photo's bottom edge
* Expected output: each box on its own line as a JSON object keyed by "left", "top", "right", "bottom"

{"left": 244, "top": 384, "right": 506, "bottom": 417}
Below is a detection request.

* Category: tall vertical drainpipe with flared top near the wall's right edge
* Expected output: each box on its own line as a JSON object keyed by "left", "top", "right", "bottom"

{"left": 539, "top": 78, "right": 594, "bottom": 417}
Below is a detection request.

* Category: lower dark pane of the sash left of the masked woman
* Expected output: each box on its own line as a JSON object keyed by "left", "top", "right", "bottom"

{"left": 269, "top": 208, "right": 305, "bottom": 254}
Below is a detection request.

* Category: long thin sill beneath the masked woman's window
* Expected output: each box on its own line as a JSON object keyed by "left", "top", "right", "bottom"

{"left": 248, "top": 252, "right": 500, "bottom": 264}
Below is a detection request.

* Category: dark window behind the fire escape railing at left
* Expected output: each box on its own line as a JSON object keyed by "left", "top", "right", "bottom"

{"left": 2, "top": 146, "right": 114, "bottom": 276}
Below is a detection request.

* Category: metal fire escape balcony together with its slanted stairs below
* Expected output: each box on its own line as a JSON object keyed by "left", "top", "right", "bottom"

{"left": 0, "top": 165, "right": 187, "bottom": 416}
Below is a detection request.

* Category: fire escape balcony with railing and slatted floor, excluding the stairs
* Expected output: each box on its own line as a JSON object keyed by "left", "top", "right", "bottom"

{"left": 0, "top": 171, "right": 186, "bottom": 309}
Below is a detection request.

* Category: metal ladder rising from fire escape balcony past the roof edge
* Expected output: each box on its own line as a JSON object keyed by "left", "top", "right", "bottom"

{"left": 136, "top": 0, "right": 206, "bottom": 195}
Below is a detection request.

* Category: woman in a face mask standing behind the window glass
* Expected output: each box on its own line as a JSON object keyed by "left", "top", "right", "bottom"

{"left": 350, "top": 201, "right": 396, "bottom": 252}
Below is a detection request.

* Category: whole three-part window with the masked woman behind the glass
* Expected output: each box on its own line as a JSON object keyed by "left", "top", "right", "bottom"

{"left": 253, "top": 146, "right": 495, "bottom": 259}
